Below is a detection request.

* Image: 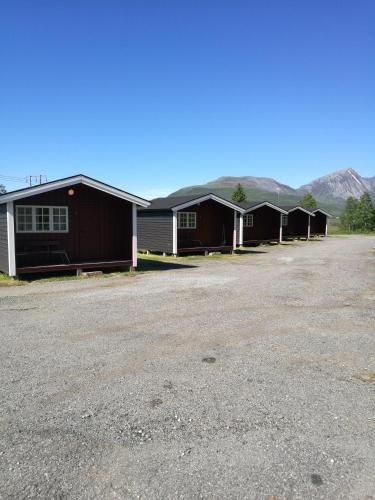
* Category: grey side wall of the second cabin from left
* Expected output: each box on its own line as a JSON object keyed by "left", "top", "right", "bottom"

{"left": 138, "top": 210, "right": 173, "bottom": 253}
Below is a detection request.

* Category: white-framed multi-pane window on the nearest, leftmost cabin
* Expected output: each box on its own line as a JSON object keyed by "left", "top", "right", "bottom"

{"left": 16, "top": 205, "right": 69, "bottom": 233}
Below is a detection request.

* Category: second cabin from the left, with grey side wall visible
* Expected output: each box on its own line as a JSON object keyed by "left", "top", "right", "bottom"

{"left": 138, "top": 193, "right": 241, "bottom": 255}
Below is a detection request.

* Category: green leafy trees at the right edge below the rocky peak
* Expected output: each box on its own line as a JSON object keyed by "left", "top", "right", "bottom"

{"left": 340, "top": 193, "right": 375, "bottom": 232}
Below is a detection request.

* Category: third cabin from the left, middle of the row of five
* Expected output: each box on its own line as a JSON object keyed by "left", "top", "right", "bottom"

{"left": 237, "top": 201, "right": 288, "bottom": 246}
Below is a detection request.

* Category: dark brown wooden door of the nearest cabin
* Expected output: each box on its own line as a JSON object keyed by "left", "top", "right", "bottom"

{"left": 79, "top": 204, "right": 101, "bottom": 261}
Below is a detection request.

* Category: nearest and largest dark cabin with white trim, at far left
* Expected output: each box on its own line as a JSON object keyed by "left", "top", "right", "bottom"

{"left": 0, "top": 175, "right": 149, "bottom": 276}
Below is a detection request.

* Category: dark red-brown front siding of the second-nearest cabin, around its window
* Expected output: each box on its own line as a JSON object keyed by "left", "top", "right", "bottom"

{"left": 177, "top": 200, "right": 234, "bottom": 248}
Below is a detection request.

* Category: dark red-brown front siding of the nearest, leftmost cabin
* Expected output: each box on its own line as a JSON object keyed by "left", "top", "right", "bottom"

{"left": 15, "top": 184, "right": 133, "bottom": 265}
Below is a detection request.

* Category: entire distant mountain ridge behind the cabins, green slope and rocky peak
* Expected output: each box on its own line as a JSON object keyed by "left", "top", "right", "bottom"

{"left": 170, "top": 168, "right": 375, "bottom": 212}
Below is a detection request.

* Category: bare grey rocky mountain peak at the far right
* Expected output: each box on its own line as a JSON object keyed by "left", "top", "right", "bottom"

{"left": 298, "top": 168, "right": 375, "bottom": 202}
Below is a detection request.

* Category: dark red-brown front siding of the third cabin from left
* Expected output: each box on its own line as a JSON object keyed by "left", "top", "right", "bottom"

{"left": 243, "top": 206, "right": 280, "bottom": 244}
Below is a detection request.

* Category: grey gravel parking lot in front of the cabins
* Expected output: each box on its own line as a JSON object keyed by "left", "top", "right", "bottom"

{"left": 0, "top": 236, "right": 375, "bottom": 500}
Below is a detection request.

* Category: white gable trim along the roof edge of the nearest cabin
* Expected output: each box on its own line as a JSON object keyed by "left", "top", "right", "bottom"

{"left": 0, "top": 175, "right": 150, "bottom": 208}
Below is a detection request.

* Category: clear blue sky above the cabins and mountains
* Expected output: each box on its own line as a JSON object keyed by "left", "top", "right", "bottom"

{"left": 0, "top": 0, "right": 375, "bottom": 197}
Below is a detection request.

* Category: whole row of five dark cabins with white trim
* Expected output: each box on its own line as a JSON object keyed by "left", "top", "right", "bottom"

{"left": 0, "top": 175, "right": 329, "bottom": 276}
